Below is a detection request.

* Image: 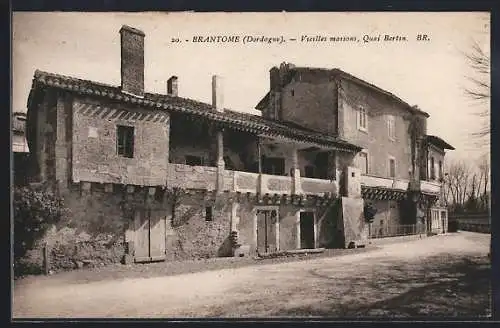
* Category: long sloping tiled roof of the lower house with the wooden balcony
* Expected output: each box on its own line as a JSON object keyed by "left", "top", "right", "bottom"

{"left": 32, "top": 70, "right": 361, "bottom": 151}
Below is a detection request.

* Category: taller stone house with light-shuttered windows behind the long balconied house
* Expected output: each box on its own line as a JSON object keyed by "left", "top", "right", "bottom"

{"left": 256, "top": 63, "right": 454, "bottom": 237}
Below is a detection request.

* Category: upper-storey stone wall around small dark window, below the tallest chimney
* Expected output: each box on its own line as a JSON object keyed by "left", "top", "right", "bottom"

{"left": 71, "top": 98, "right": 169, "bottom": 186}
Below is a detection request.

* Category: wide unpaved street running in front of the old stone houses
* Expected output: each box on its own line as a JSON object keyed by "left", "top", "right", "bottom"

{"left": 13, "top": 232, "right": 490, "bottom": 318}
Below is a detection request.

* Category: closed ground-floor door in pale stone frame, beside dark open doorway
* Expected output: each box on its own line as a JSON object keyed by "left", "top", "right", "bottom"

{"left": 257, "top": 210, "right": 278, "bottom": 254}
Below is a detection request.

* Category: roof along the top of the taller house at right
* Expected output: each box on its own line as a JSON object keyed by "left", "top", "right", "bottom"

{"left": 255, "top": 66, "right": 429, "bottom": 117}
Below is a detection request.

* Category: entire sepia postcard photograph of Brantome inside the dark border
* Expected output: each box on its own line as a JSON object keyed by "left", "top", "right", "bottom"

{"left": 11, "top": 12, "right": 492, "bottom": 320}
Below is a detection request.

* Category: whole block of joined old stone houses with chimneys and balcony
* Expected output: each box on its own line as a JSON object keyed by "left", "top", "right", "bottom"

{"left": 23, "top": 26, "right": 449, "bottom": 262}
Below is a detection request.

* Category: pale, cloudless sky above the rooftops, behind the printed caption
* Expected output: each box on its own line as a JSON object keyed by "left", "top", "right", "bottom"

{"left": 12, "top": 12, "right": 490, "bottom": 163}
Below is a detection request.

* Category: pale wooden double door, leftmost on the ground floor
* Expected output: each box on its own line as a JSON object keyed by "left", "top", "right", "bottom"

{"left": 134, "top": 209, "right": 166, "bottom": 263}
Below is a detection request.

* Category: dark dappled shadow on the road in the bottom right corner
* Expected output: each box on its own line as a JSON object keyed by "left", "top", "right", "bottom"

{"left": 205, "top": 255, "right": 491, "bottom": 319}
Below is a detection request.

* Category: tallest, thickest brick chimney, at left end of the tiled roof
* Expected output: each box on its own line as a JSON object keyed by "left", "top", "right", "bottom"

{"left": 120, "top": 25, "right": 145, "bottom": 97}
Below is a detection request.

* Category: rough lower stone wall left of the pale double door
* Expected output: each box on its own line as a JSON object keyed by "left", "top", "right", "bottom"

{"left": 18, "top": 188, "right": 129, "bottom": 272}
